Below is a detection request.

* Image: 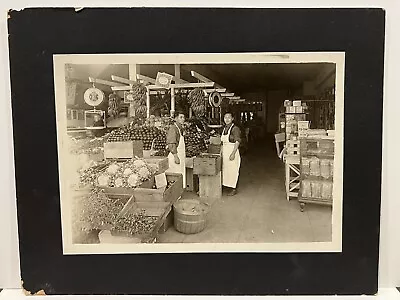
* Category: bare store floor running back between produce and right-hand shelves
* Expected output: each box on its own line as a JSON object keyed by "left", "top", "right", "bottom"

{"left": 159, "top": 139, "right": 332, "bottom": 243}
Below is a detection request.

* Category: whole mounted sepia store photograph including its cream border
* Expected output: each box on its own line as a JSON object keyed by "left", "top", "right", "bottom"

{"left": 53, "top": 52, "right": 345, "bottom": 254}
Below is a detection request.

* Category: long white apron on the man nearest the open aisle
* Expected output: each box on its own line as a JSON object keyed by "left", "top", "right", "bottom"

{"left": 221, "top": 124, "right": 240, "bottom": 188}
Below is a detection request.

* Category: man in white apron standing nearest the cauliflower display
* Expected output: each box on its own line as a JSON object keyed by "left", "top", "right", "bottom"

{"left": 167, "top": 112, "right": 186, "bottom": 188}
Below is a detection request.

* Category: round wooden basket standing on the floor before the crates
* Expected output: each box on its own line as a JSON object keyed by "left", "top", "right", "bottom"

{"left": 174, "top": 200, "right": 209, "bottom": 234}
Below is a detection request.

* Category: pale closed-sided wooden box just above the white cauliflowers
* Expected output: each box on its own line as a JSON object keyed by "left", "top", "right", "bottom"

{"left": 104, "top": 141, "right": 143, "bottom": 159}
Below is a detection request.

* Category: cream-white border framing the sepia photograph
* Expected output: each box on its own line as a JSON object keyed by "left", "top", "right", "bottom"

{"left": 53, "top": 52, "right": 345, "bottom": 255}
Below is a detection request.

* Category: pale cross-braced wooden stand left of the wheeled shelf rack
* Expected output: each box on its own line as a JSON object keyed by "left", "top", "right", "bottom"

{"left": 284, "top": 155, "right": 300, "bottom": 201}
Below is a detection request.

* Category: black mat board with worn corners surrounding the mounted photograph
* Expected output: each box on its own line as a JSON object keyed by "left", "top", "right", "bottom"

{"left": 8, "top": 8, "right": 385, "bottom": 295}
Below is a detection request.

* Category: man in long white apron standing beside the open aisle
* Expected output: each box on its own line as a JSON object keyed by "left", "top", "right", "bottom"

{"left": 221, "top": 112, "right": 241, "bottom": 196}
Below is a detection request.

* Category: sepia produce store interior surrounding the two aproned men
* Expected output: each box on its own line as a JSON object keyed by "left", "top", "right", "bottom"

{"left": 65, "top": 63, "right": 336, "bottom": 244}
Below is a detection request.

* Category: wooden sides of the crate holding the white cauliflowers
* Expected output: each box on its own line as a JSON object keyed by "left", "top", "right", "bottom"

{"left": 105, "top": 173, "right": 183, "bottom": 202}
